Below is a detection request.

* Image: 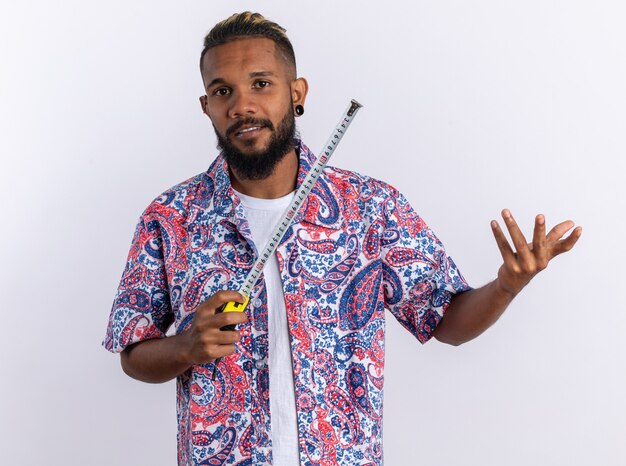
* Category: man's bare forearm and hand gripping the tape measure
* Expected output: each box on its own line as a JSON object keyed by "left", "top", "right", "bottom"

{"left": 121, "top": 291, "right": 248, "bottom": 383}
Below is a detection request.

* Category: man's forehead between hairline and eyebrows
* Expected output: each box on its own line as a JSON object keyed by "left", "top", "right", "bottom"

{"left": 202, "top": 37, "right": 286, "bottom": 83}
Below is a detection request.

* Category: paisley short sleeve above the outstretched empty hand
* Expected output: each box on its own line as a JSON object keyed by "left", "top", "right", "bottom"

{"left": 382, "top": 191, "right": 471, "bottom": 343}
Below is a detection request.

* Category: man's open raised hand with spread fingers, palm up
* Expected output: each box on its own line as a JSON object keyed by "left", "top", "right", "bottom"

{"left": 491, "top": 209, "right": 582, "bottom": 296}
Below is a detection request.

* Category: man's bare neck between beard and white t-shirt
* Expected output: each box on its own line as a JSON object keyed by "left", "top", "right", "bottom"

{"left": 230, "top": 149, "right": 298, "bottom": 199}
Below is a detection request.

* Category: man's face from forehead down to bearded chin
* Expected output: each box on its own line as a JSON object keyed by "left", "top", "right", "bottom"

{"left": 201, "top": 38, "right": 306, "bottom": 179}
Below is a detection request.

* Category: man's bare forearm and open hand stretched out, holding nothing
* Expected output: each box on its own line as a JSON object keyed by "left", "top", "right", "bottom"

{"left": 433, "top": 209, "right": 582, "bottom": 345}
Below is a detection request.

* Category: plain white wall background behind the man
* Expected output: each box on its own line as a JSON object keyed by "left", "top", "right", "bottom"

{"left": 0, "top": 0, "right": 626, "bottom": 466}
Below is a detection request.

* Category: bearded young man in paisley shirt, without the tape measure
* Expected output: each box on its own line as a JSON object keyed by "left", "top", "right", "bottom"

{"left": 105, "top": 12, "right": 581, "bottom": 466}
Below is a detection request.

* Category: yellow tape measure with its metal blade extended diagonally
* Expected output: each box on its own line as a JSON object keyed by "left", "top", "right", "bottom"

{"left": 213, "top": 99, "right": 362, "bottom": 380}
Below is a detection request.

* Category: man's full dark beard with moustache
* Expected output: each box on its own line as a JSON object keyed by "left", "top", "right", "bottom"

{"left": 213, "top": 106, "right": 298, "bottom": 180}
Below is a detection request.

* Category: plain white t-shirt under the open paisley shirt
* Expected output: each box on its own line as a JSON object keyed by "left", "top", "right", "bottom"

{"left": 237, "top": 192, "right": 300, "bottom": 466}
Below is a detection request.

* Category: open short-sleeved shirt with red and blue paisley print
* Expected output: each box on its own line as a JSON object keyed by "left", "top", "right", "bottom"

{"left": 104, "top": 143, "right": 469, "bottom": 466}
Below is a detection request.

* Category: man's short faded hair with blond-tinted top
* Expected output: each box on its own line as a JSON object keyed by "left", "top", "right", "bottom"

{"left": 200, "top": 11, "right": 296, "bottom": 81}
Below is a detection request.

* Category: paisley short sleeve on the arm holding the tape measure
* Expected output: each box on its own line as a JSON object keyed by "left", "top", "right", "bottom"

{"left": 102, "top": 213, "right": 174, "bottom": 353}
